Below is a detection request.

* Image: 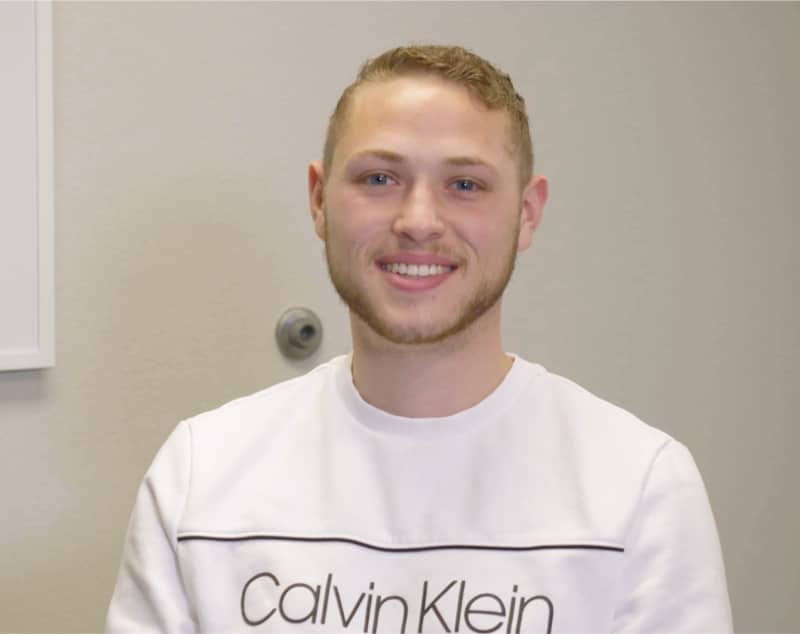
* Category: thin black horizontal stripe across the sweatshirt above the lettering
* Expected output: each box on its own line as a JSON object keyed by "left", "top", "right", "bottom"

{"left": 178, "top": 533, "right": 625, "bottom": 553}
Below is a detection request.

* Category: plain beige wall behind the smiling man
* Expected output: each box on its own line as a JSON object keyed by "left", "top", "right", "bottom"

{"left": 0, "top": 3, "right": 800, "bottom": 632}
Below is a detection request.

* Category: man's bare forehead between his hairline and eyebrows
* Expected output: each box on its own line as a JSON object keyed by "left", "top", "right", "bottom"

{"left": 337, "top": 75, "right": 514, "bottom": 167}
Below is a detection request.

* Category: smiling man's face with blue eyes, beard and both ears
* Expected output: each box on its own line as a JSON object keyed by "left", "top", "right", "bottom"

{"left": 309, "top": 77, "right": 546, "bottom": 344}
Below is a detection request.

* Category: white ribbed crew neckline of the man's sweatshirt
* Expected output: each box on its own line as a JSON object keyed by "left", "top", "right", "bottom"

{"left": 331, "top": 353, "right": 542, "bottom": 436}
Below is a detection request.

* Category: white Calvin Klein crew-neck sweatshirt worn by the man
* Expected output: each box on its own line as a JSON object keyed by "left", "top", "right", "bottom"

{"left": 107, "top": 357, "right": 732, "bottom": 634}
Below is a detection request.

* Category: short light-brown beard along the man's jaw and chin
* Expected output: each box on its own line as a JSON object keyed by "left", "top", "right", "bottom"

{"left": 325, "top": 227, "right": 519, "bottom": 345}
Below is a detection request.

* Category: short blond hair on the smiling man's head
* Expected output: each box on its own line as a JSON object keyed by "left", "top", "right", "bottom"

{"left": 323, "top": 45, "right": 533, "bottom": 186}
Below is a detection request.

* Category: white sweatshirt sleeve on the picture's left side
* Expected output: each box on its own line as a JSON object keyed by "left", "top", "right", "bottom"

{"left": 106, "top": 422, "right": 196, "bottom": 634}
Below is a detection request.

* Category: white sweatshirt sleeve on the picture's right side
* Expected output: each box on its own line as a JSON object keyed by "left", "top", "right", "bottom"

{"left": 612, "top": 440, "right": 733, "bottom": 634}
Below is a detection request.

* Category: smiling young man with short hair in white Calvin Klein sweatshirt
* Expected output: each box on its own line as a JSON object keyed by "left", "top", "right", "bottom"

{"left": 108, "top": 46, "right": 732, "bottom": 634}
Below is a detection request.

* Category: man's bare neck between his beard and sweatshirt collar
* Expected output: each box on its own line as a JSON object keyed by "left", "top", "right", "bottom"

{"left": 351, "top": 304, "right": 513, "bottom": 418}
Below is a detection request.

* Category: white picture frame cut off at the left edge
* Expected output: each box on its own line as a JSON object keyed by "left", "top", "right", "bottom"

{"left": 0, "top": 2, "right": 55, "bottom": 371}
